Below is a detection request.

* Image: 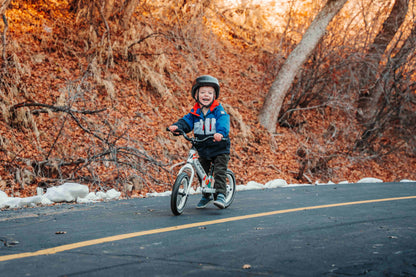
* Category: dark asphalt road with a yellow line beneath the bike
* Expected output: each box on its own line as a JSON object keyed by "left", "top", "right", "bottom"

{"left": 0, "top": 180, "right": 416, "bottom": 276}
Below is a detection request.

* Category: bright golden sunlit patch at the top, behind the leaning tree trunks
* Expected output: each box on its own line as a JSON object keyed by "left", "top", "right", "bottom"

{"left": 218, "top": 0, "right": 416, "bottom": 49}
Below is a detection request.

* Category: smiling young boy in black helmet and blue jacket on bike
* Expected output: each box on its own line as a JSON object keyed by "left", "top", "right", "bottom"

{"left": 169, "top": 75, "right": 230, "bottom": 209}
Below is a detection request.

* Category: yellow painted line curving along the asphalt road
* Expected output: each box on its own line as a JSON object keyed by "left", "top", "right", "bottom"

{"left": 0, "top": 195, "right": 416, "bottom": 262}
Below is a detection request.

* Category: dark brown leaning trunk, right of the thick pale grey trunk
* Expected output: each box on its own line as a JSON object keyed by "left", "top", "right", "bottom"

{"left": 357, "top": 0, "right": 409, "bottom": 122}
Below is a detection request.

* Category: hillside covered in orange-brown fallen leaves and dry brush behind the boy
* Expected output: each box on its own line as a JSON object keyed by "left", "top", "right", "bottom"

{"left": 0, "top": 0, "right": 416, "bottom": 196}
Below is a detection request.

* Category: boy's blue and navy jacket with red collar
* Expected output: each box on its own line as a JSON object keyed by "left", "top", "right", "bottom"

{"left": 174, "top": 100, "right": 230, "bottom": 159}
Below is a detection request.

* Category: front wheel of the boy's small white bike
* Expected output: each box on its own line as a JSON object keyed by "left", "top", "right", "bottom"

{"left": 170, "top": 172, "right": 190, "bottom": 215}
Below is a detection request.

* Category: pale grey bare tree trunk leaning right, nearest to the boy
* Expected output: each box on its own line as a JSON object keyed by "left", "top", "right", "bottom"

{"left": 259, "top": 0, "right": 347, "bottom": 133}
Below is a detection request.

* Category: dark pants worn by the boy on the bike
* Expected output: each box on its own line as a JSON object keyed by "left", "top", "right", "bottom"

{"left": 199, "top": 154, "right": 230, "bottom": 196}
